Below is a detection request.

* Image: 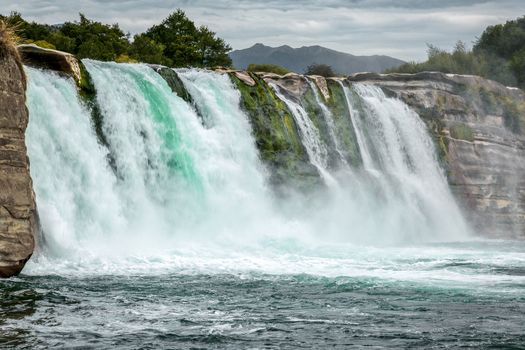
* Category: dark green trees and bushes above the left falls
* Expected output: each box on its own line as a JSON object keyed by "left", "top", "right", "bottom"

{"left": 0, "top": 10, "right": 231, "bottom": 67}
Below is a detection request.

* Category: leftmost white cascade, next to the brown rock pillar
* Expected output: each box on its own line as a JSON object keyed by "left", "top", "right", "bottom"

{"left": 26, "top": 67, "right": 125, "bottom": 254}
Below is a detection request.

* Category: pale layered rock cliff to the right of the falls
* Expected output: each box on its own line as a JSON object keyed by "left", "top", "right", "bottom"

{"left": 348, "top": 73, "right": 525, "bottom": 239}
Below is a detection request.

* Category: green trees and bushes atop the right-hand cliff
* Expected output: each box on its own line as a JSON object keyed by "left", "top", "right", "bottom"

{"left": 386, "top": 17, "right": 525, "bottom": 88}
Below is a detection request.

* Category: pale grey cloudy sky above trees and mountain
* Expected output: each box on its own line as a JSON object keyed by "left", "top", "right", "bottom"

{"left": 0, "top": 0, "right": 525, "bottom": 60}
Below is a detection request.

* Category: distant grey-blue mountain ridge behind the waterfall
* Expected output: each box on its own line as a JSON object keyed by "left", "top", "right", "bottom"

{"left": 230, "top": 44, "right": 405, "bottom": 75}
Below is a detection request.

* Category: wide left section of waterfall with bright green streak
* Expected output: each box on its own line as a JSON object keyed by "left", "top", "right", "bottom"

{"left": 26, "top": 60, "right": 278, "bottom": 262}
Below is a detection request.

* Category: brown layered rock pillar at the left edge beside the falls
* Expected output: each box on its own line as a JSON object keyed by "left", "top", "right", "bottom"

{"left": 0, "top": 40, "right": 38, "bottom": 277}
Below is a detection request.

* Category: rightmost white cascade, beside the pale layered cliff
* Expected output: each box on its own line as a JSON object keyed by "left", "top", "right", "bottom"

{"left": 343, "top": 84, "right": 468, "bottom": 239}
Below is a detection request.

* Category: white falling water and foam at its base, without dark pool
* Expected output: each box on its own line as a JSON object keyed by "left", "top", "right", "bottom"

{"left": 25, "top": 61, "right": 474, "bottom": 279}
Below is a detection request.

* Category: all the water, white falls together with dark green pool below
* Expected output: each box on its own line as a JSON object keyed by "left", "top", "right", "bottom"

{"left": 0, "top": 65, "right": 525, "bottom": 349}
